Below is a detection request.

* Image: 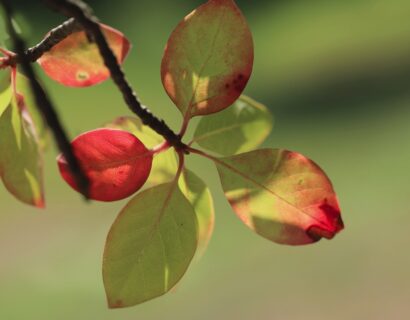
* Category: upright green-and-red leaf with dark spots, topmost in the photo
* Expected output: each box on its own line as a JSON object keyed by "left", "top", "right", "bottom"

{"left": 161, "top": 0, "right": 253, "bottom": 118}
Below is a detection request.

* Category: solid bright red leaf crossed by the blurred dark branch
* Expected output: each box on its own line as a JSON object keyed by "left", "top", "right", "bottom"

{"left": 58, "top": 129, "right": 152, "bottom": 201}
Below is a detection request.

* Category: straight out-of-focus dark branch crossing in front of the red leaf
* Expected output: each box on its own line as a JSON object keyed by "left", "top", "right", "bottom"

{"left": 1, "top": 0, "right": 89, "bottom": 197}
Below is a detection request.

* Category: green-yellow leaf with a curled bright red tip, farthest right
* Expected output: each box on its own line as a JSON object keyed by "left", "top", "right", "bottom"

{"left": 215, "top": 149, "right": 343, "bottom": 245}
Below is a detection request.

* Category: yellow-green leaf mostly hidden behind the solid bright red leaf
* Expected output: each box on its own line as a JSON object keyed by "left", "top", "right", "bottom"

{"left": 105, "top": 117, "right": 178, "bottom": 185}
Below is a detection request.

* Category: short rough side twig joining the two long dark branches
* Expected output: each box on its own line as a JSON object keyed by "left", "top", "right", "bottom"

{"left": 6, "top": 18, "right": 82, "bottom": 65}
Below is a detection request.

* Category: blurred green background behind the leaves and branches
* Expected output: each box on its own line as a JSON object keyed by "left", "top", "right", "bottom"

{"left": 0, "top": 0, "right": 410, "bottom": 320}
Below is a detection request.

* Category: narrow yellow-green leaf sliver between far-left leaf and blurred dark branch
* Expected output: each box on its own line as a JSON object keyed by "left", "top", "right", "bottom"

{"left": 16, "top": 73, "right": 50, "bottom": 149}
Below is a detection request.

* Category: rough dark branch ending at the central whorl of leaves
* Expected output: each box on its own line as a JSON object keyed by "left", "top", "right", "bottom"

{"left": 44, "top": 0, "right": 186, "bottom": 150}
